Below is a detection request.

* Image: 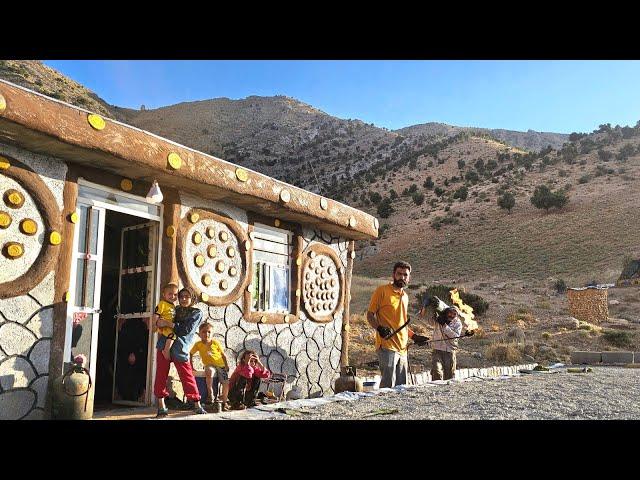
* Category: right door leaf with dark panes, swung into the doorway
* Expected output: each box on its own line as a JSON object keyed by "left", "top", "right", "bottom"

{"left": 112, "top": 222, "right": 158, "bottom": 405}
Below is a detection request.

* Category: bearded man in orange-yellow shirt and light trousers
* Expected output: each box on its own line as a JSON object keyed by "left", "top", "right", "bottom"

{"left": 367, "top": 262, "right": 428, "bottom": 388}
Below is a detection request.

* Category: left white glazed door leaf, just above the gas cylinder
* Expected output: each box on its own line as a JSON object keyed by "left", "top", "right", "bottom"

{"left": 64, "top": 200, "right": 105, "bottom": 381}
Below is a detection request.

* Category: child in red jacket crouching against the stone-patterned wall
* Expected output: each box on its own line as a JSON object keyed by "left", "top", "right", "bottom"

{"left": 229, "top": 350, "right": 271, "bottom": 410}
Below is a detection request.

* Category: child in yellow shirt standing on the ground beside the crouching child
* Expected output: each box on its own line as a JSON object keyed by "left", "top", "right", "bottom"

{"left": 190, "top": 322, "right": 229, "bottom": 411}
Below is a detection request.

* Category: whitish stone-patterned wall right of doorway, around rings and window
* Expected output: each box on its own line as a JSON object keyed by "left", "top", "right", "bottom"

{"left": 168, "top": 194, "right": 349, "bottom": 398}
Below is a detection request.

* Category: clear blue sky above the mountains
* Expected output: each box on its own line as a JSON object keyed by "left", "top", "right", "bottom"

{"left": 44, "top": 60, "right": 640, "bottom": 133}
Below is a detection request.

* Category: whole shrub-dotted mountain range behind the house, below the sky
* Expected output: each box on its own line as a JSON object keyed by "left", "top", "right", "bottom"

{"left": 0, "top": 61, "right": 640, "bottom": 283}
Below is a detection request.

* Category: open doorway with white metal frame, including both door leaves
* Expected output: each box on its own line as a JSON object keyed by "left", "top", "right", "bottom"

{"left": 64, "top": 180, "right": 162, "bottom": 408}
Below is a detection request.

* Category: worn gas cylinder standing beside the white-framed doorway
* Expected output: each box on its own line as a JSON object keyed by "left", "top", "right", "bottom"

{"left": 51, "top": 364, "right": 93, "bottom": 420}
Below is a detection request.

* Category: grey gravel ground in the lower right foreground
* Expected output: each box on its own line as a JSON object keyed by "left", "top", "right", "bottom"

{"left": 268, "top": 367, "right": 640, "bottom": 420}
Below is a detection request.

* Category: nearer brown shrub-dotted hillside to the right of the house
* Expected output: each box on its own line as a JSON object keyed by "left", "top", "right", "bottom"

{"left": 356, "top": 122, "right": 640, "bottom": 285}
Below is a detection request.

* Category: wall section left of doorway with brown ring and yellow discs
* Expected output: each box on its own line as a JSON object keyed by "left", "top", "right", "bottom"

{"left": 0, "top": 144, "right": 67, "bottom": 420}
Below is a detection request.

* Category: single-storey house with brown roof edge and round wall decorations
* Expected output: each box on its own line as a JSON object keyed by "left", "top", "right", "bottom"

{"left": 0, "top": 80, "right": 378, "bottom": 419}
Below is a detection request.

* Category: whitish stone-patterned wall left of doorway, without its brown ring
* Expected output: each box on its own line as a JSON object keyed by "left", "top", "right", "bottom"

{"left": 0, "top": 143, "right": 67, "bottom": 420}
